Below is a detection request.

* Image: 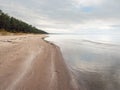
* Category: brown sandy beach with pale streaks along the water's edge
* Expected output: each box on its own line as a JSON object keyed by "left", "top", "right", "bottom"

{"left": 0, "top": 35, "right": 79, "bottom": 90}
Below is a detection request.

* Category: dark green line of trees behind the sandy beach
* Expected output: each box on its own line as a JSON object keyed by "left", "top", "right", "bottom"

{"left": 0, "top": 10, "right": 46, "bottom": 34}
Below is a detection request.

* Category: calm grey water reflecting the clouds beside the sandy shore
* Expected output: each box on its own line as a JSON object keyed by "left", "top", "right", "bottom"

{"left": 46, "top": 34, "right": 120, "bottom": 90}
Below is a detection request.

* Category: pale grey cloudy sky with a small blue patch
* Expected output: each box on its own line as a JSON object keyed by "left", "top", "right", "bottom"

{"left": 0, "top": 0, "right": 120, "bottom": 33}
